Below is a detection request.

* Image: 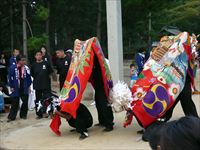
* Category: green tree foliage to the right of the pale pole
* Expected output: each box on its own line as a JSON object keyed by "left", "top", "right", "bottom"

{"left": 122, "top": 0, "right": 200, "bottom": 53}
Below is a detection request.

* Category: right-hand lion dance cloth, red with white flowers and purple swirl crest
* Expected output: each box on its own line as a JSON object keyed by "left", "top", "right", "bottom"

{"left": 113, "top": 32, "right": 198, "bottom": 128}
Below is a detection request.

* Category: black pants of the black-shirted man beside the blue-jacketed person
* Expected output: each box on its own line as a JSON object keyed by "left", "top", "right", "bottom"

{"left": 35, "top": 90, "right": 51, "bottom": 117}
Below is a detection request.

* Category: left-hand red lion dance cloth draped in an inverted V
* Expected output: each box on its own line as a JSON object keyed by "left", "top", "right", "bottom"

{"left": 50, "top": 38, "right": 113, "bottom": 135}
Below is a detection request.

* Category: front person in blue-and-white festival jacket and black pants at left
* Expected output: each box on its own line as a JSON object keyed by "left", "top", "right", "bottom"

{"left": 7, "top": 55, "right": 32, "bottom": 122}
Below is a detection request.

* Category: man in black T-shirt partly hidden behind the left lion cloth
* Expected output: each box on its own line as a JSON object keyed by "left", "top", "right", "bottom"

{"left": 56, "top": 49, "right": 71, "bottom": 90}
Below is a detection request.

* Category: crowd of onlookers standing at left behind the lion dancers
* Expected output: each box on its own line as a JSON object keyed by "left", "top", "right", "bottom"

{"left": 0, "top": 46, "right": 72, "bottom": 122}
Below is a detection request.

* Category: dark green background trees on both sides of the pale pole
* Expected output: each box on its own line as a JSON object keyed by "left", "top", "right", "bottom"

{"left": 0, "top": 0, "right": 200, "bottom": 57}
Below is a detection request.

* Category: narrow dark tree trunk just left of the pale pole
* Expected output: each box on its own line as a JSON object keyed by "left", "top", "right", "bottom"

{"left": 97, "top": 0, "right": 102, "bottom": 41}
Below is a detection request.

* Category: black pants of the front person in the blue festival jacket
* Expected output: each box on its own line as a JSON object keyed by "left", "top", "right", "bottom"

{"left": 8, "top": 95, "right": 28, "bottom": 120}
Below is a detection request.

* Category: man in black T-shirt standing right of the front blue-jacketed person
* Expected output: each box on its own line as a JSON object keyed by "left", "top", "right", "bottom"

{"left": 31, "top": 51, "right": 53, "bottom": 119}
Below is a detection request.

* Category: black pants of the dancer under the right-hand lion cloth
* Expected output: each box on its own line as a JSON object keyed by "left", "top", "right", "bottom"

{"left": 164, "top": 75, "right": 198, "bottom": 121}
